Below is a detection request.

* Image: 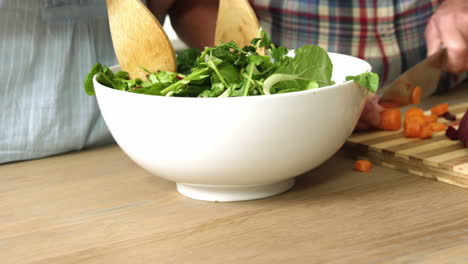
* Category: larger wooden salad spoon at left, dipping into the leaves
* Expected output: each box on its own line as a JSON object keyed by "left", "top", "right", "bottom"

{"left": 107, "top": 0, "right": 176, "bottom": 79}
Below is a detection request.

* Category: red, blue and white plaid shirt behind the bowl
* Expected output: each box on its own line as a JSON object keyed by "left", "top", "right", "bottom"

{"left": 250, "top": 0, "right": 459, "bottom": 91}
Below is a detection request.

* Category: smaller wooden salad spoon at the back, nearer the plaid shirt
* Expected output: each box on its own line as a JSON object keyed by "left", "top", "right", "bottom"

{"left": 214, "top": 0, "right": 260, "bottom": 48}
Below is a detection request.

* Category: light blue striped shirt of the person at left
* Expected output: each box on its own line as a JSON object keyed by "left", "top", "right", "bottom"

{"left": 0, "top": 0, "right": 117, "bottom": 163}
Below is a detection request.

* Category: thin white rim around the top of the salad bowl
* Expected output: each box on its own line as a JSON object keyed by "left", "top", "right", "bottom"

{"left": 93, "top": 52, "right": 372, "bottom": 101}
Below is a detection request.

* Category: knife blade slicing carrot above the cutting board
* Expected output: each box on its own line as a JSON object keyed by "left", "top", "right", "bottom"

{"left": 379, "top": 47, "right": 447, "bottom": 107}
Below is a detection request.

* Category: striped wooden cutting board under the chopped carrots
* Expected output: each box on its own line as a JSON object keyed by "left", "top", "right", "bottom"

{"left": 343, "top": 103, "right": 468, "bottom": 188}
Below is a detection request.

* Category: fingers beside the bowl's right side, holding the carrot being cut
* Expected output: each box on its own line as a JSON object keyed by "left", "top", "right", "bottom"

{"left": 354, "top": 94, "right": 384, "bottom": 131}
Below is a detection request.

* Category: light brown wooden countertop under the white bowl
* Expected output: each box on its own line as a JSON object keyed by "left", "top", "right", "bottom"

{"left": 0, "top": 85, "right": 468, "bottom": 264}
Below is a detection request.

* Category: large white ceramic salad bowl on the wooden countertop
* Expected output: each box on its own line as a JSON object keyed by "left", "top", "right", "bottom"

{"left": 94, "top": 53, "right": 371, "bottom": 202}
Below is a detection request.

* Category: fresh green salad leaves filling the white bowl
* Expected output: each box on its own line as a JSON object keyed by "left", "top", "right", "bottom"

{"left": 84, "top": 30, "right": 379, "bottom": 97}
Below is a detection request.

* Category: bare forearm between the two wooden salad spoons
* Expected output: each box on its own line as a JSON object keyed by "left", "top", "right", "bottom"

{"left": 148, "top": 0, "right": 219, "bottom": 49}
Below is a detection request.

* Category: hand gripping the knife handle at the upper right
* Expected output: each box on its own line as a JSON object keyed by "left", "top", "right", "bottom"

{"left": 425, "top": 0, "right": 468, "bottom": 73}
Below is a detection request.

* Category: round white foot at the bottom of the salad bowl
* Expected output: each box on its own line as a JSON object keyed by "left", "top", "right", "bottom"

{"left": 177, "top": 178, "right": 295, "bottom": 202}
